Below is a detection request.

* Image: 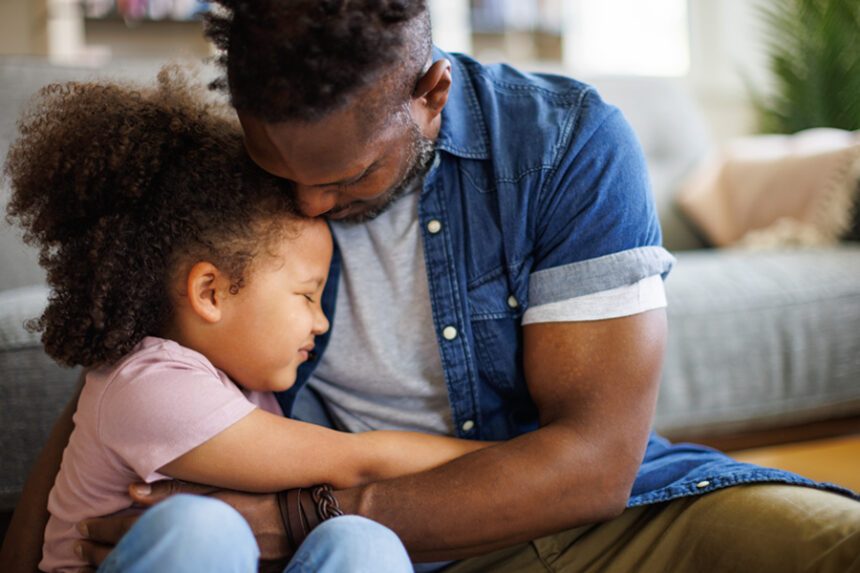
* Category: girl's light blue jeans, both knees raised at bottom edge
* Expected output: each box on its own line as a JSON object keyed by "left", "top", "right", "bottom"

{"left": 99, "top": 495, "right": 412, "bottom": 573}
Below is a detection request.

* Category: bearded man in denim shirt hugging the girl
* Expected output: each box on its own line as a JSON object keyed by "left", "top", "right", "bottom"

{"left": 3, "top": 0, "right": 860, "bottom": 572}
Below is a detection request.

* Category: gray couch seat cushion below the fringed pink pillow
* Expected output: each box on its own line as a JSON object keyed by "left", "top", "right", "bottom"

{"left": 657, "top": 245, "right": 860, "bottom": 436}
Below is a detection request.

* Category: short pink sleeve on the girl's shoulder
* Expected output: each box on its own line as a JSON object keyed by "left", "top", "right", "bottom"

{"left": 98, "top": 352, "right": 255, "bottom": 482}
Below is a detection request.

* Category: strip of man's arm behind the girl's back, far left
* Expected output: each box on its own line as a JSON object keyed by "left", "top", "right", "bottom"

{"left": 0, "top": 374, "right": 83, "bottom": 573}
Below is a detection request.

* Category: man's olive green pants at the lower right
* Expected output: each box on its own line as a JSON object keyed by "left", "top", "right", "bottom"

{"left": 444, "top": 484, "right": 860, "bottom": 573}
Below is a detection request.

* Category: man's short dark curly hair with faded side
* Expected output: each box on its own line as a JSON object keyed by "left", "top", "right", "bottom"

{"left": 206, "top": 0, "right": 432, "bottom": 122}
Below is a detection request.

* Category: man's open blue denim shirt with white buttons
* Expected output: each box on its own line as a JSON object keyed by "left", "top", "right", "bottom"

{"left": 278, "top": 50, "right": 856, "bottom": 506}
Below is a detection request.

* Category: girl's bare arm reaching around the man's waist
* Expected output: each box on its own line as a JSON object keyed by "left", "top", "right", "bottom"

{"left": 159, "top": 409, "right": 493, "bottom": 492}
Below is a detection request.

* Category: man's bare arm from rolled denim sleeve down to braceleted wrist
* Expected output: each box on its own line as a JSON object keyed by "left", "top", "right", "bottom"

{"left": 338, "top": 309, "right": 666, "bottom": 560}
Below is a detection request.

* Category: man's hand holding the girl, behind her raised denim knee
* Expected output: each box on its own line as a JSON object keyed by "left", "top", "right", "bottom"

{"left": 78, "top": 480, "right": 290, "bottom": 566}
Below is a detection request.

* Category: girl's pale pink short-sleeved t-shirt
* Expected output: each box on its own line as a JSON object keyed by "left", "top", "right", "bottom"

{"left": 39, "top": 337, "right": 281, "bottom": 571}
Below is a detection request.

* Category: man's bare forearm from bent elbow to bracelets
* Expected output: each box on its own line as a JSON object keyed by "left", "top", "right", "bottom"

{"left": 338, "top": 425, "right": 642, "bottom": 560}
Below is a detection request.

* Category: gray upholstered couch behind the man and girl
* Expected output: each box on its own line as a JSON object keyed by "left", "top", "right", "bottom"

{"left": 0, "top": 58, "right": 860, "bottom": 511}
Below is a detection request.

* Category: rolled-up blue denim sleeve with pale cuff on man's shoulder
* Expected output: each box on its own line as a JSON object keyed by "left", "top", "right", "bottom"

{"left": 529, "top": 93, "right": 675, "bottom": 307}
